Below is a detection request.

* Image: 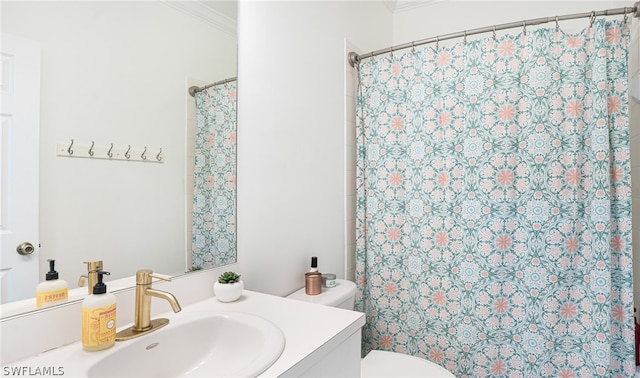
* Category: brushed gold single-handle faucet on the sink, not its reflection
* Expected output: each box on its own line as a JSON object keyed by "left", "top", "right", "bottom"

{"left": 116, "top": 269, "right": 182, "bottom": 341}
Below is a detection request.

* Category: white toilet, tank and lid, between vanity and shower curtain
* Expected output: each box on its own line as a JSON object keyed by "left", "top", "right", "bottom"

{"left": 287, "top": 279, "right": 455, "bottom": 378}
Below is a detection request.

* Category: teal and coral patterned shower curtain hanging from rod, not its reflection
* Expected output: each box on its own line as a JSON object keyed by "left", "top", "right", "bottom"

{"left": 356, "top": 19, "right": 635, "bottom": 378}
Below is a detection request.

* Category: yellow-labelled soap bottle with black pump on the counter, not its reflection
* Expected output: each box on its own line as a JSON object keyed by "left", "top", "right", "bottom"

{"left": 82, "top": 270, "right": 116, "bottom": 352}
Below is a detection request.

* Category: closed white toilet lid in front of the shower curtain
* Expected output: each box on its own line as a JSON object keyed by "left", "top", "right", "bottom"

{"left": 360, "top": 350, "right": 455, "bottom": 378}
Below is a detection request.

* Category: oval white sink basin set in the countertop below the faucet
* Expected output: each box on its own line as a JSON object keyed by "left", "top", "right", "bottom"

{"left": 89, "top": 312, "right": 285, "bottom": 378}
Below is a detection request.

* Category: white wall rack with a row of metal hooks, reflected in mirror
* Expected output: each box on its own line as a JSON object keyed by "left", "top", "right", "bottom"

{"left": 56, "top": 139, "right": 165, "bottom": 163}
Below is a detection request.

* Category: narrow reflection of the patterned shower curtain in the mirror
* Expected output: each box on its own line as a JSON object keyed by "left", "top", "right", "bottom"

{"left": 192, "top": 82, "right": 236, "bottom": 268}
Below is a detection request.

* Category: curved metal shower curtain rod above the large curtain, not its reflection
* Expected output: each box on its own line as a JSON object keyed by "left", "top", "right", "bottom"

{"left": 349, "top": 1, "right": 640, "bottom": 67}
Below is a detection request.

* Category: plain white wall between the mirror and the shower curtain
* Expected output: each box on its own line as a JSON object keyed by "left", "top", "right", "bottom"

{"left": 238, "top": 0, "right": 392, "bottom": 295}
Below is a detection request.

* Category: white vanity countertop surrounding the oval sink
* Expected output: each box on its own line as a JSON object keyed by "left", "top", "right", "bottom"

{"left": 2, "top": 290, "right": 365, "bottom": 377}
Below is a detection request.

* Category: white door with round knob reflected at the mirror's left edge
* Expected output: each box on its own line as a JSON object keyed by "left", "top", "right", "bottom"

{"left": 0, "top": 33, "right": 40, "bottom": 303}
